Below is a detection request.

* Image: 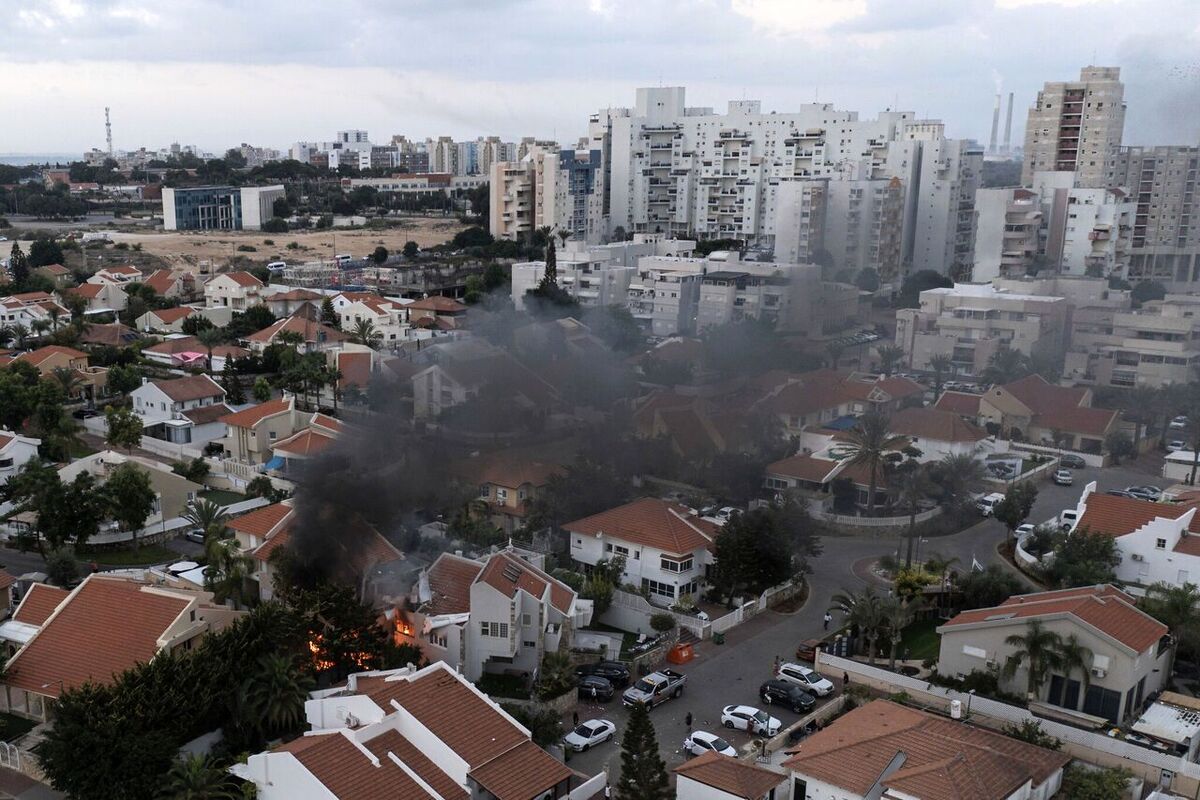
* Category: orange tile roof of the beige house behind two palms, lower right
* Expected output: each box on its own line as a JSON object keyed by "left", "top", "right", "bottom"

{"left": 942, "top": 587, "right": 1168, "bottom": 652}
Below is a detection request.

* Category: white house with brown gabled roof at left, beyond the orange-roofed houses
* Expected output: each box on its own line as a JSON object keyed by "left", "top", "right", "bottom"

{"left": 130, "top": 375, "right": 233, "bottom": 445}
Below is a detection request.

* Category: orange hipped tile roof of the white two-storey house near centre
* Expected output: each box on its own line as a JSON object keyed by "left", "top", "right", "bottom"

{"left": 565, "top": 498, "right": 718, "bottom": 555}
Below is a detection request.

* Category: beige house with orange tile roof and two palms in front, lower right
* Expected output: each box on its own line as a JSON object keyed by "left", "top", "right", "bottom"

{"left": 937, "top": 585, "right": 1174, "bottom": 724}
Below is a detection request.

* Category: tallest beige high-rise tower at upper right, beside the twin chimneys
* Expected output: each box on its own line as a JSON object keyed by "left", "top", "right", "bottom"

{"left": 1021, "top": 67, "right": 1126, "bottom": 188}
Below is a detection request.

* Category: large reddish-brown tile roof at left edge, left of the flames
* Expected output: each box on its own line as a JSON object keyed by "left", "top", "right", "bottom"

{"left": 5, "top": 575, "right": 190, "bottom": 697}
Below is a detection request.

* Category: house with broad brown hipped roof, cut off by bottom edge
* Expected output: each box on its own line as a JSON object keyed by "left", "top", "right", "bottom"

{"left": 784, "top": 700, "right": 1070, "bottom": 800}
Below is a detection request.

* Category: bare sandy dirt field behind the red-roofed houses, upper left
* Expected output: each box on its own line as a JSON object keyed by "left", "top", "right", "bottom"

{"left": 103, "top": 217, "right": 464, "bottom": 267}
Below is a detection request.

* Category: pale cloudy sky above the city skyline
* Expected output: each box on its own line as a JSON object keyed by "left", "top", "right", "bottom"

{"left": 0, "top": 0, "right": 1200, "bottom": 152}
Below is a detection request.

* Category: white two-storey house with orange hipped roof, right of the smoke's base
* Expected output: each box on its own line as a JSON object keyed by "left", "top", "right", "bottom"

{"left": 564, "top": 498, "right": 719, "bottom": 606}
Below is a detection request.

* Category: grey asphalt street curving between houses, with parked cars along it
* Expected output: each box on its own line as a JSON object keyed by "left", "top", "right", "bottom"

{"left": 565, "top": 456, "right": 1166, "bottom": 776}
